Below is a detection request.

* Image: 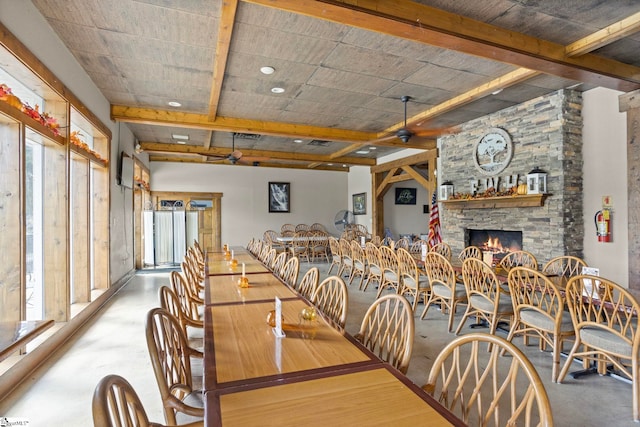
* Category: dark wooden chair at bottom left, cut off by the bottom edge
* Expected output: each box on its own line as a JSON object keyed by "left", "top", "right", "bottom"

{"left": 91, "top": 375, "right": 204, "bottom": 427}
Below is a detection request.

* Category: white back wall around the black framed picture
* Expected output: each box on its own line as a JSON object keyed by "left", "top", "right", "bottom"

{"left": 151, "top": 162, "right": 349, "bottom": 246}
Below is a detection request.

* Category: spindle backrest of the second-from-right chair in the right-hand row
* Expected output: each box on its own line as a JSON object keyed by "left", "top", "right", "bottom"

{"left": 509, "top": 267, "right": 564, "bottom": 331}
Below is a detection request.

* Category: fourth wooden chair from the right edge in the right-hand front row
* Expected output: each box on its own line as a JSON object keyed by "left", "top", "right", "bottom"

{"left": 420, "top": 252, "right": 467, "bottom": 332}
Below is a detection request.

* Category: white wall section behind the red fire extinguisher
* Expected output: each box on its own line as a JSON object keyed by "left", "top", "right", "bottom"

{"left": 582, "top": 88, "right": 629, "bottom": 286}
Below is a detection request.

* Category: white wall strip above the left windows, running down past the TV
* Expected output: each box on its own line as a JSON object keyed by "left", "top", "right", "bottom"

{"left": 0, "top": 0, "right": 134, "bottom": 283}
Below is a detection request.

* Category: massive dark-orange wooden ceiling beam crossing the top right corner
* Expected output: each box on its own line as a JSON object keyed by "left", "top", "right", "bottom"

{"left": 244, "top": 0, "right": 640, "bottom": 92}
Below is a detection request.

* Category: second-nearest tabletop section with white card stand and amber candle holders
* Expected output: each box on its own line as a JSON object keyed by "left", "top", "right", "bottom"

{"left": 204, "top": 298, "right": 372, "bottom": 391}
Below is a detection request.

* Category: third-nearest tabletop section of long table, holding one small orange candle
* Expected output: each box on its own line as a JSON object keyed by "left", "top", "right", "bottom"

{"left": 204, "top": 273, "right": 299, "bottom": 305}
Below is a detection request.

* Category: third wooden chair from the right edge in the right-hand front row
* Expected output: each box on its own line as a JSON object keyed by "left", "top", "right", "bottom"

{"left": 456, "top": 258, "right": 513, "bottom": 335}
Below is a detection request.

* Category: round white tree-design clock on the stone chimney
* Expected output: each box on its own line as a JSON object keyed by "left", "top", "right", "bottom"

{"left": 473, "top": 128, "right": 513, "bottom": 175}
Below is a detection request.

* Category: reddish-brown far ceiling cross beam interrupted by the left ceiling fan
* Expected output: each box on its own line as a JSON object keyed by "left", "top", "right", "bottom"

{"left": 140, "top": 141, "right": 376, "bottom": 167}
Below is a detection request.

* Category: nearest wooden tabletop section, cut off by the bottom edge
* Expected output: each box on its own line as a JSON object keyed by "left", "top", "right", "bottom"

{"left": 205, "top": 365, "right": 464, "bottom": 427}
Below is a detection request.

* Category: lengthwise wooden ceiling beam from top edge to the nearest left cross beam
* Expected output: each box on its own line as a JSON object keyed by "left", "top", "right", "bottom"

{"left": 208, "top": 0, "right": 238, "bottom": 120}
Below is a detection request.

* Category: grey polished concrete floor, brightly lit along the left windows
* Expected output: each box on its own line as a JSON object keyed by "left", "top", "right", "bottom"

{"left": 0, "top": 263, "right": 637, "bottom": 427}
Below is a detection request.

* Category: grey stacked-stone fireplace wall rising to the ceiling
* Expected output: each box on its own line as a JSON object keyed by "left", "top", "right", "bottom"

{"left": 438, "top": 90, "right": 584, "bottom": 265}
